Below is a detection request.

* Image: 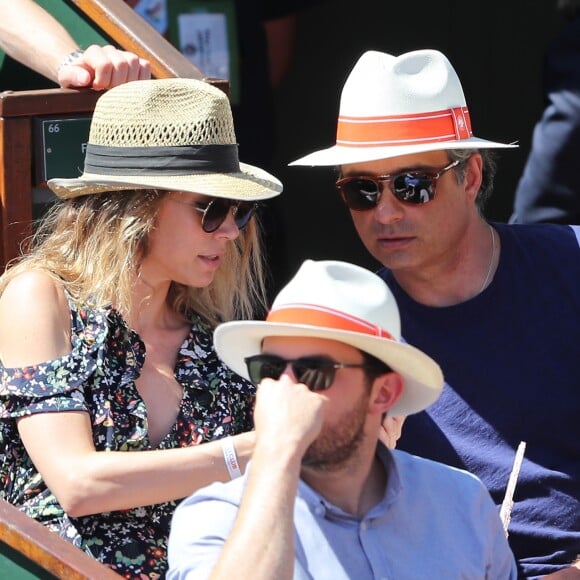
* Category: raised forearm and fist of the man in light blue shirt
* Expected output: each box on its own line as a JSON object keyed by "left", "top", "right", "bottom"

{"left": 212, "top": 376, "right": 323, "bottom": 580}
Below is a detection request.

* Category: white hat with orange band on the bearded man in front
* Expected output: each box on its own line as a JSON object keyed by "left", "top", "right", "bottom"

{"left": 214, "top": 260, "right": 443, "bottom": 415}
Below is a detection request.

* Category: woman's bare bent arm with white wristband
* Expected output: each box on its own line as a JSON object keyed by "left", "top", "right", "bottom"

{"left": 19, "top": 412, "right": 254, "bottom": 516}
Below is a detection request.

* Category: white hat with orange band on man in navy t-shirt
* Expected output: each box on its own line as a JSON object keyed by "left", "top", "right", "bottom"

{"left": 290, "top": 50, "right": 517, "bottom": 165}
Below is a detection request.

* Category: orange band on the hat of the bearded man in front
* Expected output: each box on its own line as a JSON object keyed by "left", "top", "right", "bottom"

{"left": 266, "top": 304, "right": 394, "bottom": 340}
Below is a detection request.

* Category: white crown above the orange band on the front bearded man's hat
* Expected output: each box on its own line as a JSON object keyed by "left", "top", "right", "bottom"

{"left": 272, "top": 260, "right": 401, "bottom": 342}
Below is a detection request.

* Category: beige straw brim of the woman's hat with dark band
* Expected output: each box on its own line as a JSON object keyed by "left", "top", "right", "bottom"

{"left": 48, "top": 163, "right": 282, "bottom": 201}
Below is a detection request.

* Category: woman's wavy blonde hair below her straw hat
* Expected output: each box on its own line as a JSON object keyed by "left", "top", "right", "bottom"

{"left": 0, "top": 189, "right": 266, "bottom": 326}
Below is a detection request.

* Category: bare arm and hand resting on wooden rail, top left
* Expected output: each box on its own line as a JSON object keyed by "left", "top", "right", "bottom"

{"left": 0, "top": 0, "right": 151, "bottom": 90}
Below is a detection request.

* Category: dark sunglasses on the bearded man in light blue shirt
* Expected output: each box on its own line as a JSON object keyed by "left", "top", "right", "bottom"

{"left": 244, "top": 354, "right": 367, "bottom": 391}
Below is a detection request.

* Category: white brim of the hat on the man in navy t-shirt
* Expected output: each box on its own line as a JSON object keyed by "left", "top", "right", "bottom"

{"left": 288, "top": 137, "right": 518, "bottom": 167}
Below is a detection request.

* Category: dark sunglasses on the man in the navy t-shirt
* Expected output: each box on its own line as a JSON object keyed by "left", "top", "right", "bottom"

{"left": 336, "top": 161, "right": 459, "bottom": 211}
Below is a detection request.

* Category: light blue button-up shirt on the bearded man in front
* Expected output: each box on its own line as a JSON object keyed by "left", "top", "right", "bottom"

{"left": 167, "top": 445, "right": 517, "bottom": 580}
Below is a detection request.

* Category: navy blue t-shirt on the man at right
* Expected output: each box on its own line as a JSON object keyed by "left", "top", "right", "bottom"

{"left": 379, "top": 224, "right": 580, "bottom": 578}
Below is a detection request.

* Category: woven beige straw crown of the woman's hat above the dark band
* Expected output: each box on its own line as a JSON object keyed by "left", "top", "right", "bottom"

{"left": 89, "top": 78, "right": 236, "bottom": 147}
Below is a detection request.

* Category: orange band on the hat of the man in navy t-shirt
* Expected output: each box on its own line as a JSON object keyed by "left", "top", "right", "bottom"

{"left": 336, "top": 107, "right": 473, "bottom": 147}
